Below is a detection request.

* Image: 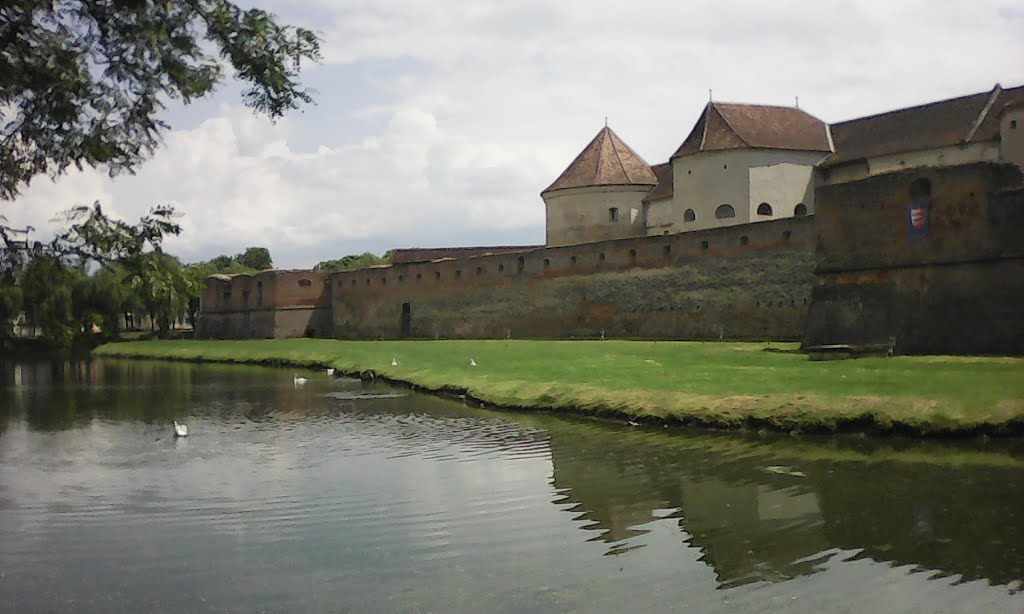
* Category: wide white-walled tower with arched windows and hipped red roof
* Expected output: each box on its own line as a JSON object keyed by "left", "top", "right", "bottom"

{"left": 646, "top": 101, "right": 834, "bottom": 234}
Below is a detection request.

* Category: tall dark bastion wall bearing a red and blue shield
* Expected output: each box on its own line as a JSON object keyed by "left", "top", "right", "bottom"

{"left": 804, "top": 163, "right": 1024, "bottom": 355}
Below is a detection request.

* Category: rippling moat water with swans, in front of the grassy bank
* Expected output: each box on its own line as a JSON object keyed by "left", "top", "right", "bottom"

{"left": 0, "top": 359, "right": 1024, "bottom": 612}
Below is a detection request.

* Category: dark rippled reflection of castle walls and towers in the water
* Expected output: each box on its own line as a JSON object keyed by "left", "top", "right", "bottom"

{"left": 550, "top": 424, "right": 1024, "bottom": 585}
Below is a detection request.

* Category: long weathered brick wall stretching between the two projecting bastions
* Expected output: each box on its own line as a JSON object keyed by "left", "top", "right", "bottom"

{"left": 330, "top": 216, "right": 815, "bottom": 340}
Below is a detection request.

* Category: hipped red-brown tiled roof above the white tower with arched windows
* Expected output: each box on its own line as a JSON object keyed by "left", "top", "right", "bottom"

{"left": 672, "top": 102, "right": 833, "bottom": 158}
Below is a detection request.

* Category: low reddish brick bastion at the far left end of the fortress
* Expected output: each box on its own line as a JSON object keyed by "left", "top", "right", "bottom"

{"left": 196, "top": 270, "right": 331, "bottom": 339}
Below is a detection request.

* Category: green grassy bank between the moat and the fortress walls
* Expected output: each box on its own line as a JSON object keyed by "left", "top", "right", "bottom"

{"left": 96, "top": 339, "right": 1024, "bottom": 434}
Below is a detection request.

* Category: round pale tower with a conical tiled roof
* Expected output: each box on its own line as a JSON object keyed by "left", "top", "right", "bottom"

{"left": 541, "top": 126, "right": 657, "bottom": 247}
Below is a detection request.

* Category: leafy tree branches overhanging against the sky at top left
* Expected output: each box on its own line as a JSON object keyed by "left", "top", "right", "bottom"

{"left": 0, "top": 0, "right": 321, "bottom": 200}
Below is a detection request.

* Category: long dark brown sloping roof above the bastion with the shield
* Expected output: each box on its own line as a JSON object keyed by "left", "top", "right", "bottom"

{"left": 825, "top": 85, "right": 1024, "bottom": 166}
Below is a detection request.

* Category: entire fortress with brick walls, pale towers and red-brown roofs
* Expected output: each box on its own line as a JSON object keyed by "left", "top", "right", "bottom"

{"left": 197, "top": 85, "right": 1024, "bottom": 354}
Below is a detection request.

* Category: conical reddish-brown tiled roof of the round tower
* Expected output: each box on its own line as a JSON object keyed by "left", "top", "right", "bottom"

{"left": 541, "top": 126, "right": 657, "bottom": 195}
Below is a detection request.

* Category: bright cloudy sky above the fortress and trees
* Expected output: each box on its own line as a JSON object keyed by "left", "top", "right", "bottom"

{"left": 3, "top": 0, "right": 1024, "bottom": 268}
